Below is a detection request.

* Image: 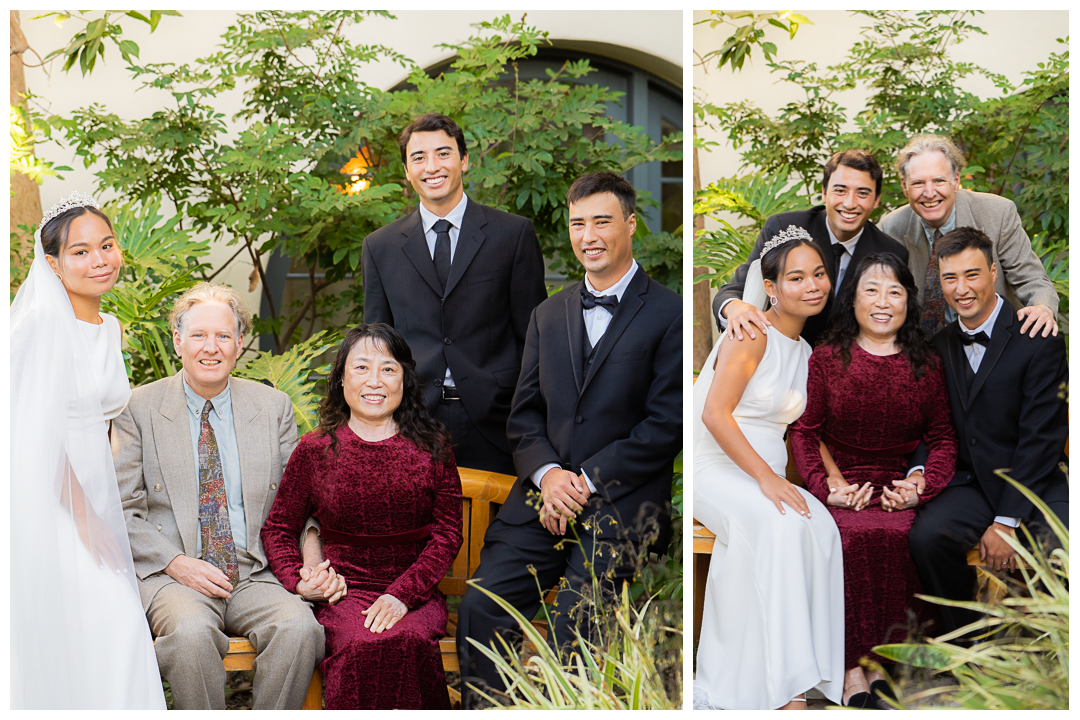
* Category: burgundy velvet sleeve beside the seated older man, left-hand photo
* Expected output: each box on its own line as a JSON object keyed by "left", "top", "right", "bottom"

{"left": 259, "top": 439, "right": 322, "bottom": 593}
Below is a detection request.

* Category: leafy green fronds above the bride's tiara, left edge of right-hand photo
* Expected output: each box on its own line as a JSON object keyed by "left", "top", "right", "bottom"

{"left": 693, "top": 167, "right": 806, "bottom": 287}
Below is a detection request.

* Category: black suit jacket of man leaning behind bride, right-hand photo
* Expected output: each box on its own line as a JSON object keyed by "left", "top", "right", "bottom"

{"left": 713, "top": 205, "right": 907, "bottom": 347}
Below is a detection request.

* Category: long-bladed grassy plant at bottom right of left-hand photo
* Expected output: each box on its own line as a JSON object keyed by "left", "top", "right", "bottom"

{"left": 469, "top": 581, "right": 681, "bottom": 710}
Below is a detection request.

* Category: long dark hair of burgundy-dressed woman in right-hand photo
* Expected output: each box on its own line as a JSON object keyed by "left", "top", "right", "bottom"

{"left": 818, "top": 253, "right": 936, "bottom": 380}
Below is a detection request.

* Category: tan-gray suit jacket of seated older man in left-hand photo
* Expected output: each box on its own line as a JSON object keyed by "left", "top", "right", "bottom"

{"left": 112, "top": 370, "right": 296, "bottom": 609}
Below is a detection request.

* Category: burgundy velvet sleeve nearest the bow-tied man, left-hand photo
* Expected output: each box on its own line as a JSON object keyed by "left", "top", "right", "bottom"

{"left": 384, "top": 456, "right": 461, "bottom": 608}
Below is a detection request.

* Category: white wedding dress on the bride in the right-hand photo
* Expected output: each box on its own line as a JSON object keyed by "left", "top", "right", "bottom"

{"left": 693, "top": 328, "right": 845, "bottom": 709}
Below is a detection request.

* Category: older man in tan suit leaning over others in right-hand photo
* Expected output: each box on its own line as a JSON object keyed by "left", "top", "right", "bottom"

{"left": 881, "top": 134, "right": 1057, "bottom": 337}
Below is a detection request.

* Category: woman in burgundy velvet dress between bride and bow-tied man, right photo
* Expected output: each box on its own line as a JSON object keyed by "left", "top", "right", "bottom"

{"left": 788, "top": 254, "right": 957, "bottom": 707}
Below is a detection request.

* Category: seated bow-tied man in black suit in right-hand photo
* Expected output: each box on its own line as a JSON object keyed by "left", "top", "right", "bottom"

{"left": 909, "top": 228, "right": 1069, "bottom": 631}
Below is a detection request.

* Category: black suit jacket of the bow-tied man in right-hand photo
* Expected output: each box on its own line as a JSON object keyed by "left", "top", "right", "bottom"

{"left": 932, "top": 301, "right": 1069, "bottom": 518}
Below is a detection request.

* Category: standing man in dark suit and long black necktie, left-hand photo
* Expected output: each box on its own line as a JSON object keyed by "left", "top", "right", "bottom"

{"left": 363, "top": 113, "right": 546, "bottom": 474}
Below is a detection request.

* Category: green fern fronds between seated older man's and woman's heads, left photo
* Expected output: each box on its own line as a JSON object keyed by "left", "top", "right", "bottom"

{"left": 233, "top": 330, "right": 340, "bottom": 435}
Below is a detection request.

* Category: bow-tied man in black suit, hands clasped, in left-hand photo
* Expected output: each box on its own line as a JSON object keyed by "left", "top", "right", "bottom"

{"left": 458, "top": 173, "right": 683, "bottom": 706}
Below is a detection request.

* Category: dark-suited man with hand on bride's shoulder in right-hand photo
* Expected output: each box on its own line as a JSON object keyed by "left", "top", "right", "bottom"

{"left": 713, "top": 150, "right": 907, "bottom": 345}
